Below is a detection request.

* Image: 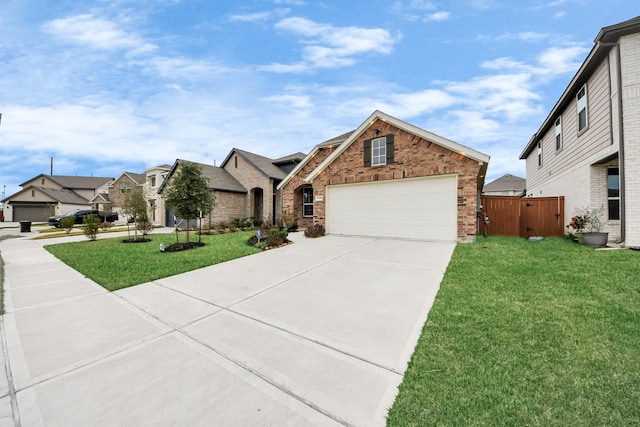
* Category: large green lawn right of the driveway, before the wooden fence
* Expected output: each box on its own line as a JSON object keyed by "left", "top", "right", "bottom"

{"left": 387, "top": 237, "right": 640, "bottom": 426}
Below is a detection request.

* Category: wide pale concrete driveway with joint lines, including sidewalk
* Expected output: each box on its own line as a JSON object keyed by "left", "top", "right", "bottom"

{"left": 0, "top": 233, "right": 455, "bottom": 426}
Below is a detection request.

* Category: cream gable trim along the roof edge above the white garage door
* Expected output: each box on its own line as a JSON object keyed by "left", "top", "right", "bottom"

{"left": 304, "top": 110, "right": 489, "bottom": 182}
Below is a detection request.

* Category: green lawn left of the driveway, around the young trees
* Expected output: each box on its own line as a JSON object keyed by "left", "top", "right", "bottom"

{"left": 45, "top": 231, "right": 260, "bottom": 291}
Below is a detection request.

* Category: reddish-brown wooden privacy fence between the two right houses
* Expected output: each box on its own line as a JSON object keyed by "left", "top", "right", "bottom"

{"left": 479, "top": 196, "right": 565, "bottom": 237}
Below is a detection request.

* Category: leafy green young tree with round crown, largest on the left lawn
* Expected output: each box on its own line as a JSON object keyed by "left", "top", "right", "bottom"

{"left": 164, "top": 162, "right": 216, "bottom": 243}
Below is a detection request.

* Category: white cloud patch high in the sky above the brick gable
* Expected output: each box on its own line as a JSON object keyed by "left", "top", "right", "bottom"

{"left": 263, "top": 17, "right": 396, "bottom": 72}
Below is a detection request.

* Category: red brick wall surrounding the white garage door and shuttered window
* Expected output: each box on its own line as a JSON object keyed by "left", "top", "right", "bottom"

{"left": 283, "top": 120, "right": 480, "bottom": 240}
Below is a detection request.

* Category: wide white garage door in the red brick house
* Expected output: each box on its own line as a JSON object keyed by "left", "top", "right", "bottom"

{"left": 326, "top": 175, "right": 458, "bottom": 241}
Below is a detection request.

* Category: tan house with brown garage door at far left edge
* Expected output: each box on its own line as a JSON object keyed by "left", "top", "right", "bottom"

{"left": 2, "top": 174, "right": 113, "bottom": 222}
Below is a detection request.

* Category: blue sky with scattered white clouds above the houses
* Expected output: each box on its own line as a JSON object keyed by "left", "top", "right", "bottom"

{"left": 0, "top": 0, "right": 640, "bottom": 196}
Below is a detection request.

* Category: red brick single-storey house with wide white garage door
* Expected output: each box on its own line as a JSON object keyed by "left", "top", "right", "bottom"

{"left": 278, "top": 111, "right": 489, "bottom": 241}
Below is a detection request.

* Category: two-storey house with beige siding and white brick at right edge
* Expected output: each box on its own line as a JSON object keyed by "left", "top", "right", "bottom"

{"left": 520, "top": 17, "right": 640, "bottom": 246}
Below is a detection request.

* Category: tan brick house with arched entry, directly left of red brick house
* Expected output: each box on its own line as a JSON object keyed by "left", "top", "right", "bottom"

{"left": 220, "top": 148, "right": 305, "bottom": 224}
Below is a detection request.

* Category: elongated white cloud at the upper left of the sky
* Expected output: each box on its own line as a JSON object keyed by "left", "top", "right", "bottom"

{"left": 42, "top": 14, "right": 157, "bottom": 54}
